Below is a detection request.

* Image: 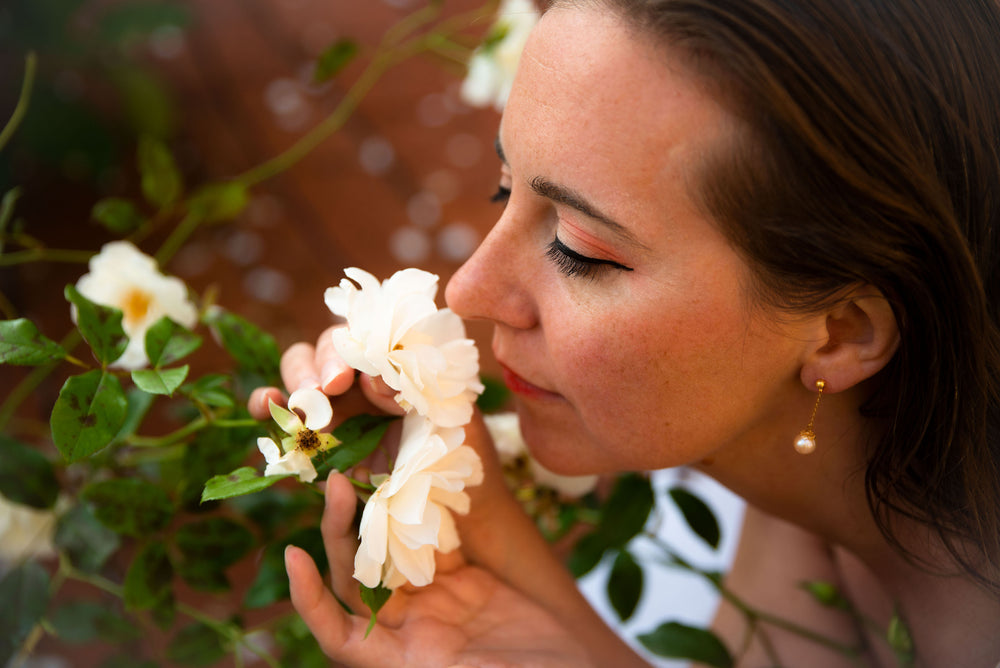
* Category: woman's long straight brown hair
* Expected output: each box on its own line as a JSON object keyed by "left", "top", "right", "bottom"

{"left": 580, "top": 0, "right": 1000, "bottom": 592}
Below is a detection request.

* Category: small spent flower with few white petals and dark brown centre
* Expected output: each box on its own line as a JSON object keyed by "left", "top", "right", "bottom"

{"left": 257, "top": 389, "right": 339, "bottom": 482}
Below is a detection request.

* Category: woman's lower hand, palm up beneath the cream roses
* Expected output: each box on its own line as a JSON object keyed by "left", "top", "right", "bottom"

{"left": 285, "top": 474, "right": 590, "bottom": 668}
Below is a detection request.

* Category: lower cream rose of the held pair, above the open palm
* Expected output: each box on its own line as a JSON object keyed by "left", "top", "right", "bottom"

{"left": 354, "top": 413, "right": 483, "bottom": 589}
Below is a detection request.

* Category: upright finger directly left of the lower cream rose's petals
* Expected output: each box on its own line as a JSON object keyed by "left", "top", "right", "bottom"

{"left": 320, "top": 473, "right": 365, "bottom": 613}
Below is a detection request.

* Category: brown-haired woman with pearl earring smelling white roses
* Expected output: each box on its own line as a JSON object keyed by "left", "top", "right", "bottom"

{"left": 252, "top": 0, "right": 1000, "bottom": 668}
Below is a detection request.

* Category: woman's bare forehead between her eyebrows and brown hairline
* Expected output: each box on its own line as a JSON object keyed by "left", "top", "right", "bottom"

{"left": 501, "top": 5, "right": 729, "bottom": 222}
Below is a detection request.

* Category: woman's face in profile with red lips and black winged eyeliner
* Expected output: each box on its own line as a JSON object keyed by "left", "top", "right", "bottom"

{"left": 446, "top": 8, "right": 805, "bottom": 473}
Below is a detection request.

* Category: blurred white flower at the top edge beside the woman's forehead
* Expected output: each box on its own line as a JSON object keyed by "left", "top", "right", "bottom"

{"left": 461, "top": 0, "right": 540, "bottom": 111}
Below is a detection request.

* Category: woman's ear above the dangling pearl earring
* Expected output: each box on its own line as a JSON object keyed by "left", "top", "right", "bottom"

{"left": 802, "top": 285, "right": 899, "bottom": 392}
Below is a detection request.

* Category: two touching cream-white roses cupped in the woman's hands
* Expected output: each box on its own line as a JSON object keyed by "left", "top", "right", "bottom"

{"left": 325, "top": 268, "right": 483, "bottom": 589}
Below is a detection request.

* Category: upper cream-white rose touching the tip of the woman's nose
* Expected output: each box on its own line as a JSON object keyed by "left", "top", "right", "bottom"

{"left": 325, "top": 267, "right": 483, "bottom": 427}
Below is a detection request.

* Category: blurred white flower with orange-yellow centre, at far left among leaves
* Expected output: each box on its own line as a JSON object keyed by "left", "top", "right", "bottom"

{"left": 73, "top": 241, "right": 198, "bottom": 370}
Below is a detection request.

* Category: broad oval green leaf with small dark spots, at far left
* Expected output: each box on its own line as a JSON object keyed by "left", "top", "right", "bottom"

{"left": 49, "top": 369, "right": 128, "bottom": 462}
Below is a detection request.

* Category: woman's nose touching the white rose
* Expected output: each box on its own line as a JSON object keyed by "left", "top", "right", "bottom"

{"left": 445, "top": 209, "right": 541, "bottom": 329}
